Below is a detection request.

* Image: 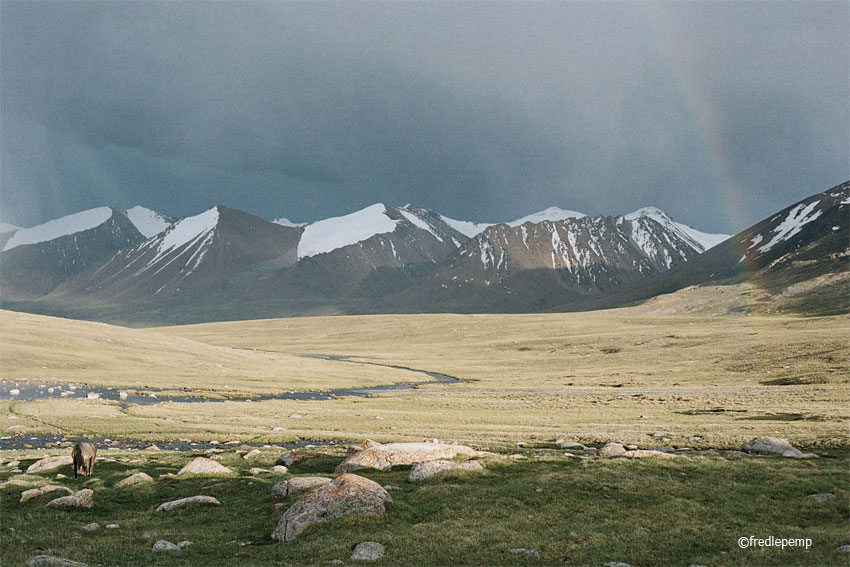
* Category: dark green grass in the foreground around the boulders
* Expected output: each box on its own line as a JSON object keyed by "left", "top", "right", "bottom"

{"left": 0, "top": 448, "right": 850, "bottom": 566}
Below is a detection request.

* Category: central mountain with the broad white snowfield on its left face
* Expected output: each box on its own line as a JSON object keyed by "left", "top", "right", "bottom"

{"left": 252, "top": 203, "right": 467, "bottom": 298}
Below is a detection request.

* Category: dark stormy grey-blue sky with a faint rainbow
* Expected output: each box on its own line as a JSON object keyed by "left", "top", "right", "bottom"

{"left": 0, "top": 0, "right": 850, "bottom": 233}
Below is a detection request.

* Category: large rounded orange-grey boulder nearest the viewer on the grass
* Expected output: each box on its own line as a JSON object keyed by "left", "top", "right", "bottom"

{"left": 272, "top": 474, "right": 392, "bottom": 541}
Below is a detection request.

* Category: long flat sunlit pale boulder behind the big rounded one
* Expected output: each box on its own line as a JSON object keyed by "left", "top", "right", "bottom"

{"left": 336, "top": 439, "right": 490, "bottom": 474}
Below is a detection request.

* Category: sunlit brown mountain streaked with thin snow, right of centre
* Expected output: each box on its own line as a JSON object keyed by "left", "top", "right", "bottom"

{"left": 412, "top": 209, "right": 724, "bottom": 310}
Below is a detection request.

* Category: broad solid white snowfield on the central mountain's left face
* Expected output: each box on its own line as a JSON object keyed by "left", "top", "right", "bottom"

{"left": 298, "top": 203, "right": 399, "bottom": 258}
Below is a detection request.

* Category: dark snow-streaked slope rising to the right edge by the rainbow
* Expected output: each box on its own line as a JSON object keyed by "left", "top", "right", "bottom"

{"left": 618, "top": 181, "right": 850, "bottom": 312}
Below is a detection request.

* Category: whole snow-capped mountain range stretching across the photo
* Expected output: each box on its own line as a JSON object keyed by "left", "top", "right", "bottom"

{"left": 0, "top": 182, "right": 850, "bottom": 322}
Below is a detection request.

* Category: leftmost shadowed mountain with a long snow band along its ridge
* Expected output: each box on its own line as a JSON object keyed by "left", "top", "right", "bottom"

{"left": 0, "top": 207, "right": 144, "bottom": 299}
